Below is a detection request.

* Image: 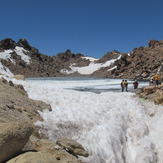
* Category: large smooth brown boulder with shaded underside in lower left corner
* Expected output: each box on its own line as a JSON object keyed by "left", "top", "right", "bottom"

{"left": 0, "top": 121, "right": 33, "bottom": 162}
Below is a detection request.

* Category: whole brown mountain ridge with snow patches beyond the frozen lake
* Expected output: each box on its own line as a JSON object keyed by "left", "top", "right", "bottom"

{"left": 0, "top": 38, "right": 163, "bottom": 78}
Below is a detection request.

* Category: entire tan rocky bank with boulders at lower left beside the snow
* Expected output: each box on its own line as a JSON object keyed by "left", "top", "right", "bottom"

{"left": 0, "top": 78, "right": 88, "bottom": 163}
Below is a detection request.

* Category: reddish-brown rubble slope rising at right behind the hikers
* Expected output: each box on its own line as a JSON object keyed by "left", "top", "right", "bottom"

{"left": 92, "top": 40, "right": 163, "bottom": 80}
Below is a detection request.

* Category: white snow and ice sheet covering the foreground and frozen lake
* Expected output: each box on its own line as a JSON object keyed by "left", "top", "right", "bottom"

{"left": 20, "top": 79, "right": 163, "bottom": 163}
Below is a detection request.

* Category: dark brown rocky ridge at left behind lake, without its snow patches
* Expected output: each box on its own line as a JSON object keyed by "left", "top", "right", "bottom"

{"left": 0, "top": 38, "right": 90, "bottom": 77}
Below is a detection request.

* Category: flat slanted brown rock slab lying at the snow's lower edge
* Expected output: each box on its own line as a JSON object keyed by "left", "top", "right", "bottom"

{"left": 56, "top": 138, "right": 89, "bottom": 157}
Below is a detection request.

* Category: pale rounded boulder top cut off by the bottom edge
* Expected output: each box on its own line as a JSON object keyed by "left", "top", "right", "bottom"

{"left": 6, "top": 152, "right": 59, "bottom": 163}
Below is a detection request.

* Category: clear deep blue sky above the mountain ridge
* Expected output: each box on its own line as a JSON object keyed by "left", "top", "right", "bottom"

{"left": 0, "top": 0, "right": 163, "bottom": 58}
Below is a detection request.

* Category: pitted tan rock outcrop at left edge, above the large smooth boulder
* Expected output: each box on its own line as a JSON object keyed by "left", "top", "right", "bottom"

{"left": 0, "top": 79, "right": 51, "bottom": 122}
